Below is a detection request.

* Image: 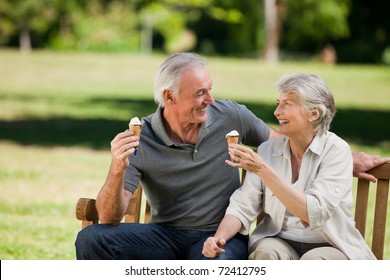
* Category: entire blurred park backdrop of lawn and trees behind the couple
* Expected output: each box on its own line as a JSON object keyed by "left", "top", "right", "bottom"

{"left": 0, "top": 0, "right": 390, "bottom": 260}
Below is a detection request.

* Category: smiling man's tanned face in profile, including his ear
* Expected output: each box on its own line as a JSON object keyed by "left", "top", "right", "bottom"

{"left": 172, "top": 68, "right": 215, "bottom": 124}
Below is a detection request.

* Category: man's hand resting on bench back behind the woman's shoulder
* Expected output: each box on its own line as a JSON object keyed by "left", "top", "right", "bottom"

{"left": 352, "top": 152, "right": 390, "bottom": 182}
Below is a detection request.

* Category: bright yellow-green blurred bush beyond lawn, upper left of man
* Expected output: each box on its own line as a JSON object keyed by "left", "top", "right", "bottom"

{"left": 51, "top": 0, "right": 140, "bottom": 52}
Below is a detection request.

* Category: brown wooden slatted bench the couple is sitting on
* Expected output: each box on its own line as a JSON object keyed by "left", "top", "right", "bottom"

{"left": 76, "top": 162, "right": 390, "bottom": 260}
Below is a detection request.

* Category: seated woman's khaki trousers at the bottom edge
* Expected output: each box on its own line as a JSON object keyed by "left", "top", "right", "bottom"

{"left": 249, "top": 237, "right": 348, "bottom": 260}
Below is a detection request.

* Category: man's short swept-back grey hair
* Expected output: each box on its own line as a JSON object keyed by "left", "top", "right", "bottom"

{"left": 154, "top": 53, "right": 207, "bottom": 107}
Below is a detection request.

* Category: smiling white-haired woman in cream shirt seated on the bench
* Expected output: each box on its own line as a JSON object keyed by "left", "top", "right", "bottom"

{"left": 203, "top": 74, "right": 375, "bottom": 260}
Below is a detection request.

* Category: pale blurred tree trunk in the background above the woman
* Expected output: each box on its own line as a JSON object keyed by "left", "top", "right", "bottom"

{"left": 264, "top": 0, "right": 279, "bottom": 64}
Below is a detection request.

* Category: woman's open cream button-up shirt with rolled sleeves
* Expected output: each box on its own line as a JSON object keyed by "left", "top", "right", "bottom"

{"left": 226, "top": 132, "right": 375, "bottom": 259}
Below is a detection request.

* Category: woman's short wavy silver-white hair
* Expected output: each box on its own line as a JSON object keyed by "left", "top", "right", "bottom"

{"left": 277, "top": 73, "right": 336, "bottom": 134}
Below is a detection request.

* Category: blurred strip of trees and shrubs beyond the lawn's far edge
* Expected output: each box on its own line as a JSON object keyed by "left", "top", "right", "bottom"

{"left": 0, "top": 0, "right": 390, "bottom": 64}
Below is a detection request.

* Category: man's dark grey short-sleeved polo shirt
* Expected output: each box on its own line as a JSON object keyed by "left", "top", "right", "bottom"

{"left": 125, "top": 100, "right": 270, "bottom": 230}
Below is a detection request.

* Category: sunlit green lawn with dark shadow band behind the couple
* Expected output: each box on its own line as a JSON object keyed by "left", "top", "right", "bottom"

{"left": 0, "top": 50, "right": 390, "bottom": 259}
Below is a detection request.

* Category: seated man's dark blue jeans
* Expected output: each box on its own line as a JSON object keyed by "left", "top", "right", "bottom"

{"left": 76, "top": 223, "right": 248, "bottom": 260}
